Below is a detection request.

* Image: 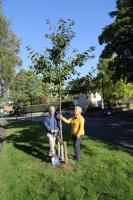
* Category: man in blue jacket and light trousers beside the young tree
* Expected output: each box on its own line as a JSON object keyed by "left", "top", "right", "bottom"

{"left": 43, "top": 106, "right": 59, "bottom": 156}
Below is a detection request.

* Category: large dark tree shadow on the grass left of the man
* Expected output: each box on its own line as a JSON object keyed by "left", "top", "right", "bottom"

{"left": 6, "top": 120, "right": 51, "bottom": 162}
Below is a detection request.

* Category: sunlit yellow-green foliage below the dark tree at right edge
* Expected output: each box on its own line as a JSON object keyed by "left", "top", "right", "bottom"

{"left": 96, "top": 58, "right": 133, "bottom": 105}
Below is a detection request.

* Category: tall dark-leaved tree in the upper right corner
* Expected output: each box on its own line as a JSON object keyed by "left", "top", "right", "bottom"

{"left": 99, "top": 0, "right": 133, "bottom": 82}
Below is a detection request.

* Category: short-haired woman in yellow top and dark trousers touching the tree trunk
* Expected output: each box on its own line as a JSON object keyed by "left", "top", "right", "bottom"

{"left": 61, "top": 106, "right": 85, "bottom": 162}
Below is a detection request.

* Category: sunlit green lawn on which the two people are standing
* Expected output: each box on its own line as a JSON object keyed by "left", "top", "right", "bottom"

{"left": 0, "top": 120, "right": 133, "bottom": 200}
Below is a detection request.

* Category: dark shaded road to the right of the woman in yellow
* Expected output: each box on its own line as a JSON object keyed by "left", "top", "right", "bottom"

{"left": 86, "top": 116, "right": 133, "bottom": 152}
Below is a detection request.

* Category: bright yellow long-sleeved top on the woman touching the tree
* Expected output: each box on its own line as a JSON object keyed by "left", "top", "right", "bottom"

{"left": 62, "top": 114, "right": 85, "bottom": 138}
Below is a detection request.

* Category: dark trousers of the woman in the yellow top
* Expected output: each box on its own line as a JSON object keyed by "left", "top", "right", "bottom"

{"left": 72, "top": 135, "right": 83, "bottom": 162}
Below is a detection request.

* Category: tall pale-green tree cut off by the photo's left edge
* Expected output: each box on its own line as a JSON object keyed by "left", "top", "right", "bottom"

{"left": 0, "top": 1, "right": 21, "bottom": 97}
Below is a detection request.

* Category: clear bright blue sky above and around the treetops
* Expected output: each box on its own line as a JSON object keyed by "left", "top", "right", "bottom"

{"left": 2, "top": 0, "right": 116, "bottom": 76}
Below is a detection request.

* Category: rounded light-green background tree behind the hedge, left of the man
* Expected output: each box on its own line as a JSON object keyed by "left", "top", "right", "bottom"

{"left": 10, "top": 69, "right": 47, "bottom": 105}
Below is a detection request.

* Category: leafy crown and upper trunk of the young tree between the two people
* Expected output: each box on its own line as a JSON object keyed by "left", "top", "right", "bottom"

{"left": 27, "top": 19, "right": 94, "bottom": 139}
